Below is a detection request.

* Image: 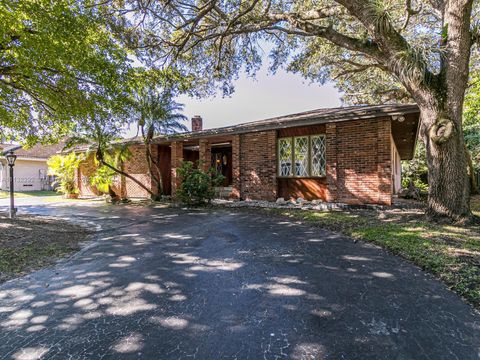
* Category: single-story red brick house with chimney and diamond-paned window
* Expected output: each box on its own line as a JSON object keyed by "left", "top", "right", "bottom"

{"left": 78, "top": 105, "right": 419, "bottom": 205}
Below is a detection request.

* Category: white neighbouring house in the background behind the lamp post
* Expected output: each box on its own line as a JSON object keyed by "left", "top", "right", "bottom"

{"left": 0, "top": 143, "right": 64, "bottom": 191}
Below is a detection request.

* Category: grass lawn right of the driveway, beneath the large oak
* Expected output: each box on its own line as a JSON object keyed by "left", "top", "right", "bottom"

{"left": 258, "top": 196, "right": 480, "bottom": 310}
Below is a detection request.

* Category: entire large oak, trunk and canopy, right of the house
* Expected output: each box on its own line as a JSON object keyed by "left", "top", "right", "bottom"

{"left": 108, "top": 0, "right": 478, "bottom": 220}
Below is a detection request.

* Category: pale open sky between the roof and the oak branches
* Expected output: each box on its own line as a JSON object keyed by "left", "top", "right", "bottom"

{"left": 176, "top": 66, "right": 341, "bottom": 129}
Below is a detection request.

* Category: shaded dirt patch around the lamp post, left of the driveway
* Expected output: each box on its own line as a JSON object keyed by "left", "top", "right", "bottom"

{"left": 0, "top": 215, "right": 93, "bottom": 282}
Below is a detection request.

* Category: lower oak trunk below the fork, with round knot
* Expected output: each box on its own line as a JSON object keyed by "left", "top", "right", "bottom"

{"left": 420, "top": 104, "right": 472, "bottom": 221}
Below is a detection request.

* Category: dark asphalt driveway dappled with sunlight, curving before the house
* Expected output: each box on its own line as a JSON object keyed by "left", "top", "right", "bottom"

{"left": 0, "top": 203, "right": 480, "bottom": 360}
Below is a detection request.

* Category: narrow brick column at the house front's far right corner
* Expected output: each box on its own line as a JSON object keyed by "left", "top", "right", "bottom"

{"left": 377, "top": 118, "right": 392, "bottom": 205}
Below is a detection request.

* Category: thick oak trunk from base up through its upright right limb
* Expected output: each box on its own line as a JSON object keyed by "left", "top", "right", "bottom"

{"left": 415, "top": 0, "right": 472, "bottom": 222}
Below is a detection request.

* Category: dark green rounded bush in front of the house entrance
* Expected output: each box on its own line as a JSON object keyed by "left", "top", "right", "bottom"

{"left": 177, "top": 161, "right": 224, "bottom": 205}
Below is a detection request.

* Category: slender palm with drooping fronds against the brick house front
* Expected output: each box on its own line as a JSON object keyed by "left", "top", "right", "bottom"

{"left": 137, "top": 88, "right": 187, "bottom": 197}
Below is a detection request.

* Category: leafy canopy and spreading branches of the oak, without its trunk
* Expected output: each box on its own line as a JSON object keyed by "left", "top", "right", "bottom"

{"left": 100, "top": 0, "right": 478, "bottom": 104}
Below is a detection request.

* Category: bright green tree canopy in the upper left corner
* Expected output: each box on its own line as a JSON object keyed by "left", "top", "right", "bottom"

{"left": 0, "top": 0, "right": 131, "bottom": 142}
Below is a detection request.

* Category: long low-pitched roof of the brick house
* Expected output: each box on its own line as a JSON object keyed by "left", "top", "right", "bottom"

{"left": 155, "top": 104, "right": 419, "bottom": 143}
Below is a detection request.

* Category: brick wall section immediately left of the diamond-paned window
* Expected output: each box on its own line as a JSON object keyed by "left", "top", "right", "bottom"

{"left": 240, "top": 130, "right": 277, "bottom": 201}
